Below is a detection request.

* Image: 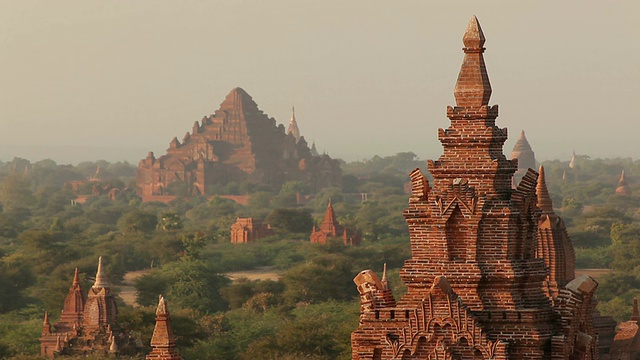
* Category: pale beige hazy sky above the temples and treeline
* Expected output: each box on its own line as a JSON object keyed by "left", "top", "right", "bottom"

{"left": 0, "top": 0, "right": 640, "bottom": 163}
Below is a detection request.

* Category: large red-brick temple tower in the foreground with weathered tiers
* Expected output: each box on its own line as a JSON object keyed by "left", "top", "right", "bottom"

{"left": 351, "top": 16, "right": 598, "bottom": 360}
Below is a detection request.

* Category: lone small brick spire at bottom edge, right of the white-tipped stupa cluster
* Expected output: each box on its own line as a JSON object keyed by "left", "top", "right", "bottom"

{"left": 147, "top": 295, "right": 180, "bottom": 360}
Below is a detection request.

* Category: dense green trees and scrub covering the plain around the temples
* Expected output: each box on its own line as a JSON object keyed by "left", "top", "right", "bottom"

{"left": 0, "top": 153, "right": 640, "bottom": 359}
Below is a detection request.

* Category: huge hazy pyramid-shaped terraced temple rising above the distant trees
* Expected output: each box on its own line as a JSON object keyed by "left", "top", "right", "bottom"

{"left": 136, "top": 88, "right": 342, "bottom": 201}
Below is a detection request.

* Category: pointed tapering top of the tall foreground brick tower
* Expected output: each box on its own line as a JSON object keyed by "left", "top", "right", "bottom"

{"left": 453, "top": 15, "right": 491, "bottom": 107}
